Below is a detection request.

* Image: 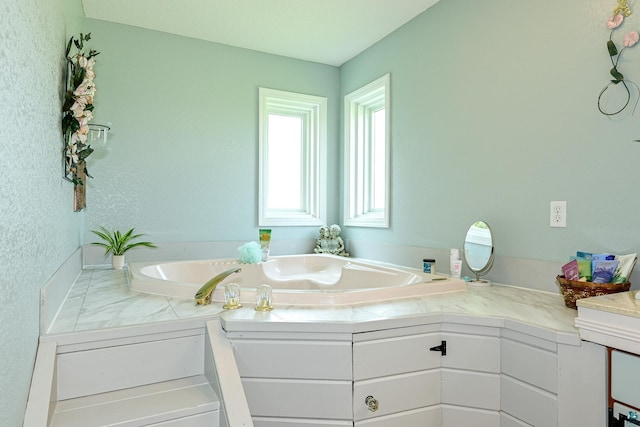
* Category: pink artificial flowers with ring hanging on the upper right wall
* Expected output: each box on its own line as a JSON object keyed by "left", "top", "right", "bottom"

{"left": 598, "top": 0, "right": 640, "bottom": 116}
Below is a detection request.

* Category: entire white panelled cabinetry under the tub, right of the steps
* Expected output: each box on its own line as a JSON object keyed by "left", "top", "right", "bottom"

{"left": 227, "top": 318, "right": 607, "bottom": 427}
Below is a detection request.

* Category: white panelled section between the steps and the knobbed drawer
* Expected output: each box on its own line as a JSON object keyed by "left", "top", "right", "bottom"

{"left": 227, "top": 332, "right": 353, "bottom": 427}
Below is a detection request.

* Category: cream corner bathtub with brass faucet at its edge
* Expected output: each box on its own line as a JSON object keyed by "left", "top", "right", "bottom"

{"left": 129, "top": 254, "right": 466, "bottom": 306}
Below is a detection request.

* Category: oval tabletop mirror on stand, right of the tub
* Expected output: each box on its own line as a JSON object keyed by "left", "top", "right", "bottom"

{"left": 462, "top": 221, "right": 493, "bottom": 284}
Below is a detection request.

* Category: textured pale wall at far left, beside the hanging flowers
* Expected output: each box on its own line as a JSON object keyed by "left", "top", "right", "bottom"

{"left": 0, "top": 0, "right": 83, "bottom": 427}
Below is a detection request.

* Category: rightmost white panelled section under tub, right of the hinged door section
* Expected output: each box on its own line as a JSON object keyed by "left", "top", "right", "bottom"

{"left": 500, "top": 329, "right": 607, "bottom": 427}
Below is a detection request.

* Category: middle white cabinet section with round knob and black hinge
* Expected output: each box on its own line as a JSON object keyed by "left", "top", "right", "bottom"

{"left": 353, "top": 324, "right": 500, "bottom": 427}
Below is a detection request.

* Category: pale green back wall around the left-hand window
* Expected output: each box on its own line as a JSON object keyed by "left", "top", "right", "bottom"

{"left": 85, "top": 19, "right": 340, "bottom": 244}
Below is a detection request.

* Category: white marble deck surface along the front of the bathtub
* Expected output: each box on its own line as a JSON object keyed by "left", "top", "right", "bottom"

{"left": 45, "top": 268, "right": 579, "bottom": 340}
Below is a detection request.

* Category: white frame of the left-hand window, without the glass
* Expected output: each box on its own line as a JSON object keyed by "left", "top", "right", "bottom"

{"left": 258, "top": 87, "right": 327, "bottom": 226}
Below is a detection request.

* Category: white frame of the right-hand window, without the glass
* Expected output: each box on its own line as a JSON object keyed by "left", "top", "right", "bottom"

{"left": 344, "top": 74, "right": 391, "bottom": 228}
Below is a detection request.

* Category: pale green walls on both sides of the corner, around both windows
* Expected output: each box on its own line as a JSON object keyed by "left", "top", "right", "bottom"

{"left": 85, "top": 0, "right": 640, "bottom": 270}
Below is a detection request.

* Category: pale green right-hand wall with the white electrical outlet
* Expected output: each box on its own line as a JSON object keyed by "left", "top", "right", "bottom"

{"left": 341, "top": 0, "right": 640, "bottom": 264}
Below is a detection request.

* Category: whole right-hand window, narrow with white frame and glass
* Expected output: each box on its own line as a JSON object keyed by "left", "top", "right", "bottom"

{"left": 344, "top": 74, "right": 390, "bottom": 228}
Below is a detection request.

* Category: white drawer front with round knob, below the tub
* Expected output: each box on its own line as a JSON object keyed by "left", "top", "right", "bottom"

{"left": 353, "top": 369, "right": 441, "bottom": 421}
